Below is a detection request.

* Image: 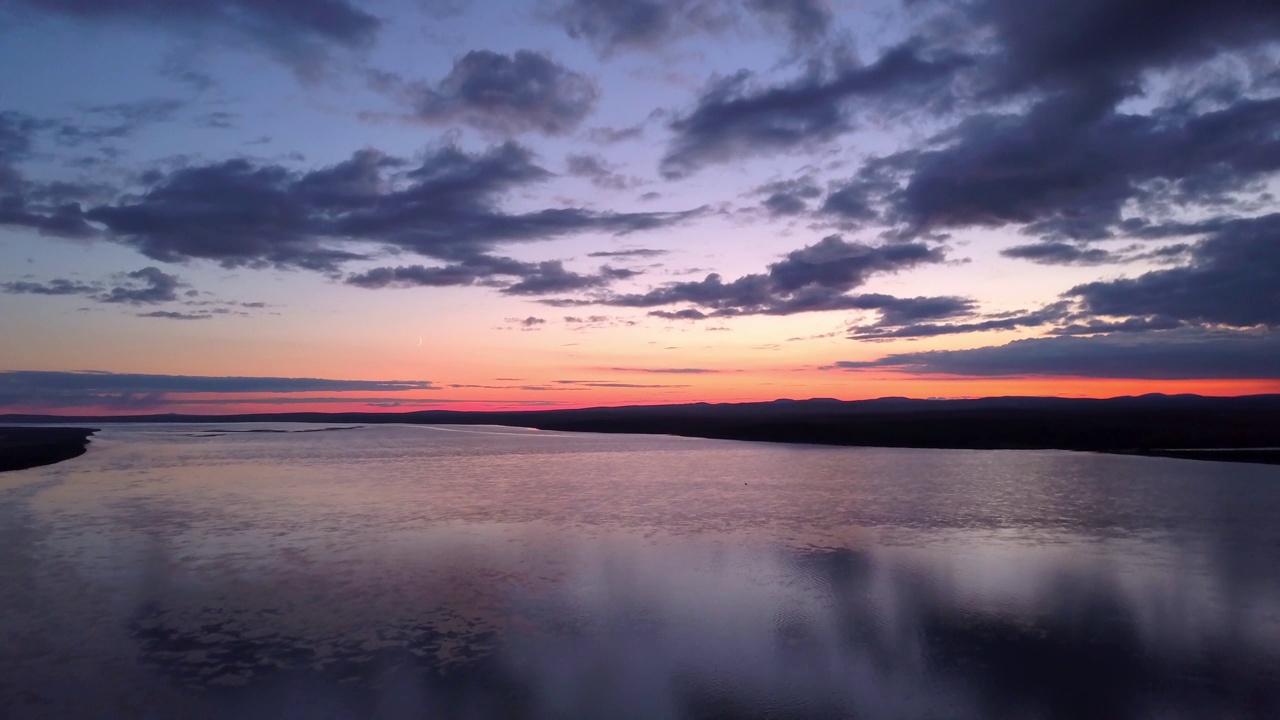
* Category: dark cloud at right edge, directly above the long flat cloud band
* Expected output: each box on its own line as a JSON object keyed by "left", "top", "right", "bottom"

{"left": 1065, "top": 214, "right": 1280, "bottom": 328}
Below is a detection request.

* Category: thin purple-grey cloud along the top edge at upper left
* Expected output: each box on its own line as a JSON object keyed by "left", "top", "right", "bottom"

{"left": 13, "top": 0, "right": 381, "bottom": 79}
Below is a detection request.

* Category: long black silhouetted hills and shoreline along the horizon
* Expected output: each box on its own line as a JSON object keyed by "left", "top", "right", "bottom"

{"left": 10, "top": 395, "right": 1280, "bottom": 452}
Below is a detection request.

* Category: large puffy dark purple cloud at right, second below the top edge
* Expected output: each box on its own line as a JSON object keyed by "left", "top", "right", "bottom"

{"left": 846, "top": 95, "right": 1280, "bottom": 240}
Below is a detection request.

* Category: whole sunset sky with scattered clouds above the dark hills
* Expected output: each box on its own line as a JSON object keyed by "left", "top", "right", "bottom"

{"left": 0, "top": 0, "right": 1280, "bottom": 414}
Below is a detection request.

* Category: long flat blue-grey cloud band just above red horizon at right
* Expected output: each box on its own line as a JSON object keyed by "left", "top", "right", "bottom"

{"left": 833, "top": 331, "right": 1280, "bottom": 379}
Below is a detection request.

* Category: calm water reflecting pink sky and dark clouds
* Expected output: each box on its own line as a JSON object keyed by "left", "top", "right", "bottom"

{"left": 0, "top": 425, "right": 1280, "bottom": 719}
